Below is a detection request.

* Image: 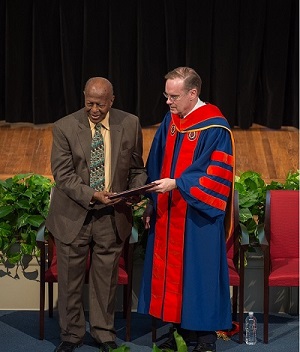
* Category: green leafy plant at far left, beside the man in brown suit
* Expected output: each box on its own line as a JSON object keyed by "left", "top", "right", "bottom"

{"left": 0, "top": 173, "right": 53, "bottom": 270}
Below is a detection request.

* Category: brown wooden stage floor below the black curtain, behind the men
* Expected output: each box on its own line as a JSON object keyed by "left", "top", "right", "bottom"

{"left": 0, "top": 121, "right": 299, "bottom": 183}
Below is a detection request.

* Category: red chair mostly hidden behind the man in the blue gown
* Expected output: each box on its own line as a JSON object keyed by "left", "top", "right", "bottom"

{"left": 227, "top": 190, "right": 249, "bottom": 343}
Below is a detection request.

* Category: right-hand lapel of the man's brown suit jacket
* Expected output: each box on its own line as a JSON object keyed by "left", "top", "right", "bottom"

{"left": 109, "top": 109, "right": 123, "bottom": 180}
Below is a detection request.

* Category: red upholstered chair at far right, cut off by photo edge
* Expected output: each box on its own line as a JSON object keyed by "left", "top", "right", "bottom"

{"left": 261, "top": 190, "right": 299, "bottom": 342}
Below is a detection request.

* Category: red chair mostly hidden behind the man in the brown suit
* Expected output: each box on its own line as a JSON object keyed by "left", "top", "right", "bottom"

{"left": 36, "top": 225, "right": 134, "bottom": 341}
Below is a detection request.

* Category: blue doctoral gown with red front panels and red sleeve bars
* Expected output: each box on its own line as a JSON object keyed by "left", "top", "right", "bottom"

{"left": 138, "top": 104, "right": 234, "bottom": 331}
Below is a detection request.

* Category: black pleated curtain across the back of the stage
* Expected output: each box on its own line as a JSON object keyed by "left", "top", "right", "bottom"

{"left": 0, "top": 0, "right": 299, "bottom": 129}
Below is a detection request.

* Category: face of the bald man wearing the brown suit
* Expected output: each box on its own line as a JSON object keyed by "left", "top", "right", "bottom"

{"left": 84, "top": 86, "right": 114, "bottom": 124}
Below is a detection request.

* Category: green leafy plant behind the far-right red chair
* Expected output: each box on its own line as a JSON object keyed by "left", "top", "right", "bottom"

{"left": 234, "top": 170, "right": 299, "bottom": 248}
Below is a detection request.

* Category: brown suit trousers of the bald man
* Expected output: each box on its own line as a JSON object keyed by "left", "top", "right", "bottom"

{"left": 56, "top": 207, "right": 123, "bottom": 343}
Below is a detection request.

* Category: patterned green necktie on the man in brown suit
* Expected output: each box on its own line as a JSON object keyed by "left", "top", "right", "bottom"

{"left": 90, "top": 123, "right": 105, "bottom": 191}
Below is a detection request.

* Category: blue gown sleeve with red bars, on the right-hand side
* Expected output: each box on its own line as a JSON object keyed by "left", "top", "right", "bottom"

{"left": 176, "top": 127, "right": 234, "bottom": 218}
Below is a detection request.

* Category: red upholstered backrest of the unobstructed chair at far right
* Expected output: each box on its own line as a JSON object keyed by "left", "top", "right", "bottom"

{"left": 265, "top": 190, "right": 299, "bottom": 261}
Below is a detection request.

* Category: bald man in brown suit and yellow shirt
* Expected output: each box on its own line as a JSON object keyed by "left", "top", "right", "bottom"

{"left": 46, "top": 77, "right": 147, "bottom": 352}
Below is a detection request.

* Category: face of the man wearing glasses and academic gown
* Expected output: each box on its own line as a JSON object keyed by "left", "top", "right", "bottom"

{"left": 164, "top": 78, "right": 198, "bottom": 117}
